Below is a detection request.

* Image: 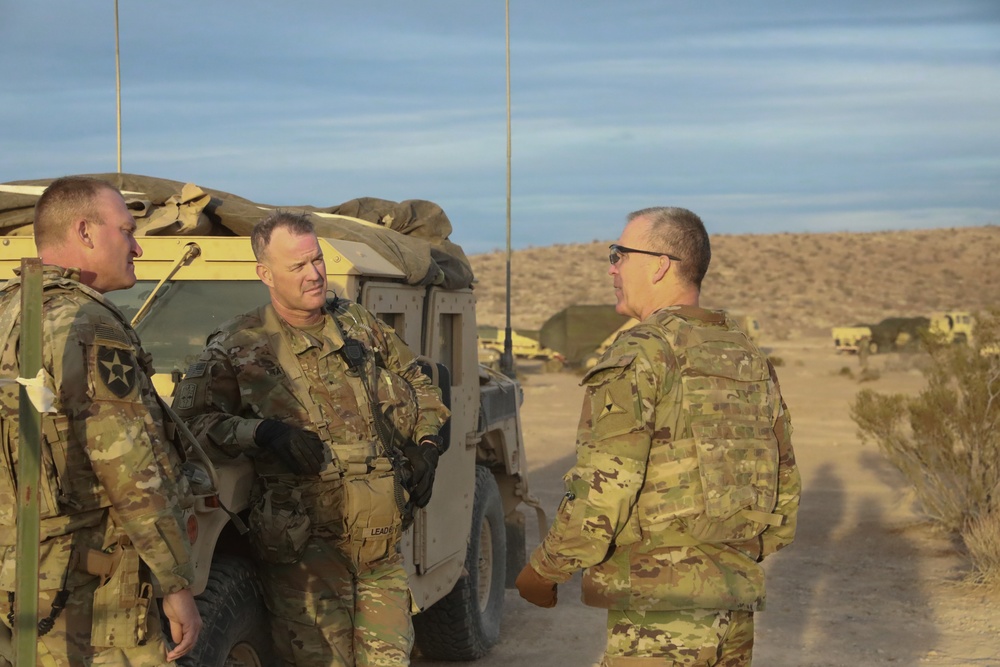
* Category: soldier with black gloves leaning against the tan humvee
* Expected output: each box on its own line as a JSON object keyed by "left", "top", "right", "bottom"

{"left": 174, "top": 211, "right": 448, "bottom": 667}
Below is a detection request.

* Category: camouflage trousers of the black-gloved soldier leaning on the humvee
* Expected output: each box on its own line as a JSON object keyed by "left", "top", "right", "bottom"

{"left": 260, "top": 537, "right": 413, "bottom": 667}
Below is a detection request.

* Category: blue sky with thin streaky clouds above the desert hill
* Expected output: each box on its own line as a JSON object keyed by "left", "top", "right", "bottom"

{"left": 0, "top": 0, "right": 1000, "bottom": 253}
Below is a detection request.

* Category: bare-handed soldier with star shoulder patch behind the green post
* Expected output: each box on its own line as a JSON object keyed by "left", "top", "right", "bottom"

{"left": 0, "top": 177, "right": 201, "bottom": 667}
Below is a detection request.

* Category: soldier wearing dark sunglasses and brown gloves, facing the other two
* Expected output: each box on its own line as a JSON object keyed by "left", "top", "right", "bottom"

{"left": 517, "top": 208, "right": 800, "bottom": 667}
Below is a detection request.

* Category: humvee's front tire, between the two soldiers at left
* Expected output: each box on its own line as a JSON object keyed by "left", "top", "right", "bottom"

{"left": 176, "top": 555, "right": 276, "bottom": 667}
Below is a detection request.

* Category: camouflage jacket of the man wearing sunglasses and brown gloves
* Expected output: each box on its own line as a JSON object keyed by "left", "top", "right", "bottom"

{"left": 531, "top": 306, "right": 801, "bottom": 610}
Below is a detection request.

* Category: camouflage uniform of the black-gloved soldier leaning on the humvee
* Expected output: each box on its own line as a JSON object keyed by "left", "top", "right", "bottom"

{"left": 174, "top": 300, "right": 448, "bottom": 667}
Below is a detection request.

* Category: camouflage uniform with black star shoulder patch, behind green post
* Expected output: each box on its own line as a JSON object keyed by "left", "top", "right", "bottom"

{"left": 0, "top": 266, "right": 194, "bottom": 666}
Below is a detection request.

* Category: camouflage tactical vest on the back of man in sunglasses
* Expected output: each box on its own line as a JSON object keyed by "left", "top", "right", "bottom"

{"left": 636, "top": 311, "right": 783, "bottom": 546}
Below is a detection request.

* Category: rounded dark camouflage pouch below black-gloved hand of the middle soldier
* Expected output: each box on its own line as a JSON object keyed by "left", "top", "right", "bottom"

{"left": 248, "top": 482, "right": 312, "bottom": 564}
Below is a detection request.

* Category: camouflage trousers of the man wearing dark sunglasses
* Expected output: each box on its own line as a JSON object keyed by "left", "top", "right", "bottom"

{"left": 601, "top": 609, "right": 753, "bottom": 667}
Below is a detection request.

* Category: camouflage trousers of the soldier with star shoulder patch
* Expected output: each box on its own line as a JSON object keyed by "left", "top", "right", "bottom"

{"left": 0, "top": 575, "right": 176, "bottom": 667}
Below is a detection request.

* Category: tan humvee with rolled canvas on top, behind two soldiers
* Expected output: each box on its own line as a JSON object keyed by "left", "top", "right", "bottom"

{"left": 0, "top": 179, "right": 546, "bottom": 667}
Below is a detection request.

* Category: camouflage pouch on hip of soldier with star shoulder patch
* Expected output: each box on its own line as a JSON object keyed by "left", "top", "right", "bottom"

{"left": 89, "top": 537, "right": 155, "bottom": 648}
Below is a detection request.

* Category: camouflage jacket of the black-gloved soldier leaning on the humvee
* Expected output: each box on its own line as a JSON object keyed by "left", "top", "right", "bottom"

{"left": 173, "top": 299, "right": 449, "bottom": 475}
